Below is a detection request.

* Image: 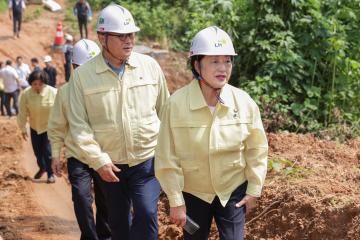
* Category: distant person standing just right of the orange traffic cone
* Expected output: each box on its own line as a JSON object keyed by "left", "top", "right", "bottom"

{"left": 74, "top": 0, "right": 92, "bottom": 39}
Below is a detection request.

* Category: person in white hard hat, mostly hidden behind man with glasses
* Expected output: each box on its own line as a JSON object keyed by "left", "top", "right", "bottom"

{"left": 48, "top": 39, "right": 111, "bottom": 240}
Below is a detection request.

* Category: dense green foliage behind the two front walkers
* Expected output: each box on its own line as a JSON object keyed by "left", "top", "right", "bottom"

{"left": 93, "top": 0, "right": 360, "bottom": 134}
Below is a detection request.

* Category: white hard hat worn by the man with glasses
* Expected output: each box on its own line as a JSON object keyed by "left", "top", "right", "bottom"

{"left": 96, "top": 4, "right": 140, "bottom": 34}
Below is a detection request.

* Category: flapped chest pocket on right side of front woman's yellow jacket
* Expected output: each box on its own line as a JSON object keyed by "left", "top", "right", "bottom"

{"left": 218, "top": 118, "right": 251, "bottom": 150}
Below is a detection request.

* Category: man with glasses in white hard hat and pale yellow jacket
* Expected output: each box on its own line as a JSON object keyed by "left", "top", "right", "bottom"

{"left": 69, "top": 4, "right": 169, "bottom": 240}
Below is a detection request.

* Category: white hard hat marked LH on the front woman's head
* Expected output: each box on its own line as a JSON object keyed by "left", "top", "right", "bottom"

{"left": 190, "top": 26, "right": 237, "bottom": 57}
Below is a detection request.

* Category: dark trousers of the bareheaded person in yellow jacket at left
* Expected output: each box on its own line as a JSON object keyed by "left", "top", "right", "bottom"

{"left": 30, "top": 128, "right": 53, "bottom": 177}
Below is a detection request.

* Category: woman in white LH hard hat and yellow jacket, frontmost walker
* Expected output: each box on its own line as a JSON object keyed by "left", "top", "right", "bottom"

{"left": 155, "top": 27, "right": 268, "bottom": 240}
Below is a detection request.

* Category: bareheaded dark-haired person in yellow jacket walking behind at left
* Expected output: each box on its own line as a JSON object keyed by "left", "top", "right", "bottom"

{"left": 17, "top": 70, "right": 56, "bottom": 183}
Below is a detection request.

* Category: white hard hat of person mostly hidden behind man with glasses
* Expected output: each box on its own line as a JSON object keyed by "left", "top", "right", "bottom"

{"left": 72, "top": 39, "right": 100, "bottom": 65}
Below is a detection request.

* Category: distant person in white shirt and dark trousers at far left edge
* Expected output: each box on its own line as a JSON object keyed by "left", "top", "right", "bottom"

{"left": 0, "top": 60, "right": 20, "bottom": 117}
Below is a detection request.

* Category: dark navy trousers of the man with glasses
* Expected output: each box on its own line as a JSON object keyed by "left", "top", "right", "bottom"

{"left": 101, "top": 158, "right": 160, "bottom": 240}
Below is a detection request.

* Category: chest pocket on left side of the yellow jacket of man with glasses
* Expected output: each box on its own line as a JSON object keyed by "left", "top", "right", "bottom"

{"left": 84, "top": 88, "right": 121, "bottom": 125}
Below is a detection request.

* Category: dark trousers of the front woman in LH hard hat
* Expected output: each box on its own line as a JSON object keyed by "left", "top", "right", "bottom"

{"left": 183, "top": 182, "right": 247, "bottom": 240}
